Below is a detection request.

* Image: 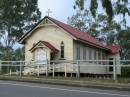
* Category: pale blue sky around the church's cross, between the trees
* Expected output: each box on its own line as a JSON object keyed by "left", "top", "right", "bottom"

{"left": 38, "top": 0, "right": 74, "bottom": 22}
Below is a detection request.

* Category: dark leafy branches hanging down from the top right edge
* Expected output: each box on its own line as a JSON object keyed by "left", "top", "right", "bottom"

{"left": 74, "top": 0, "right": 130, "bottom": 20}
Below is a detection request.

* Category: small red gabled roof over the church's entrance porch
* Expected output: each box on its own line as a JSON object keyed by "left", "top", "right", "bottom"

{"left": 30, "top": 41, "right": 59, "bottom": 53}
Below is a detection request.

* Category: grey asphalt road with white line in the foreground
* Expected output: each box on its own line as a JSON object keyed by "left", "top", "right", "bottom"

{"left": 0, "top": 81, "right": 130, "bottom": 97}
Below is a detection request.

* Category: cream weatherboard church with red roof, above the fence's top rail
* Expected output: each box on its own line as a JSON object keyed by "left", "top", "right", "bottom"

{"left": 19, "top": 16, "right": 121, "bottom": 74}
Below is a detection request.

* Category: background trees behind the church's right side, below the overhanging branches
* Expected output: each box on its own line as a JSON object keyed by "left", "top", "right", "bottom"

{"left": 68, "top": 9, "right": 130, "bottom": 59}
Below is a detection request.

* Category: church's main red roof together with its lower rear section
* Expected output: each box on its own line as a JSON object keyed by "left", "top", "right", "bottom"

{"left": 19, "top": 16, "right": 121, "bottom": 53}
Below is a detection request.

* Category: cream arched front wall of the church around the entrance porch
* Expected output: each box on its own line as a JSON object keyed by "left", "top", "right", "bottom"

{"left": 25, "top": 25, "right": 73, "bottom": 61}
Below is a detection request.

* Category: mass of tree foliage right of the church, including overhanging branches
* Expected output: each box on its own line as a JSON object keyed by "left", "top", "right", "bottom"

{"left": 72, "top": 0, "right": 130, "bottom": 59}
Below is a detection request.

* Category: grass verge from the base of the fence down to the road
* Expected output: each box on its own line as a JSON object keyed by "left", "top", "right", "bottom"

{"left": 0, "top": 75, "right": 130, "bottom": 91}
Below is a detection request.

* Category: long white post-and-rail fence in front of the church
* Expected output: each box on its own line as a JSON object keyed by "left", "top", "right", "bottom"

{"left": 0, "top": 60, "right": 130, "bottom": 80}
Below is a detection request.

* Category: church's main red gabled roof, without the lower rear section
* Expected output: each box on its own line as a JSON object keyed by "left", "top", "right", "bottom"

{"left": 19, "top": 16, "right": 121, "bottom": 51}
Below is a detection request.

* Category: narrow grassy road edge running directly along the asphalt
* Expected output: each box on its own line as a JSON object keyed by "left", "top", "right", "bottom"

{"left": 0, "top": 76, "right": 130, "bottom": 91}
